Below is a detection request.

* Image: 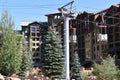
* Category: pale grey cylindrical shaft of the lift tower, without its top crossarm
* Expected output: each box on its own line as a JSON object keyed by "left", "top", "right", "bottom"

{"left": 64, "top": 15, "right": 70, "bottom": 80}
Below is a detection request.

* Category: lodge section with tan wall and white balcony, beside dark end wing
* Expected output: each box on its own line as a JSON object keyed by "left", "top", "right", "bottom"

{"left": 76, "top": 12, "right": 107, "bottom": 67}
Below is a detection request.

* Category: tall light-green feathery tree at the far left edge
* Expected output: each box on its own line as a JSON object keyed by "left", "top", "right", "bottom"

{"left": 0, "top": 11, "right": 22, "bottom": 75}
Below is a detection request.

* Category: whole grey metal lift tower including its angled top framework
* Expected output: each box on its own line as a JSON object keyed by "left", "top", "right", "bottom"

{"left": 58, "top": 1, "right": 74, "bottom": 80}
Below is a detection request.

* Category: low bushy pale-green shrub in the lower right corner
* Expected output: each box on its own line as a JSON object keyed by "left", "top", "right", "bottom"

{"left": 93, "top": 56, "right": 118, "bottom": 80}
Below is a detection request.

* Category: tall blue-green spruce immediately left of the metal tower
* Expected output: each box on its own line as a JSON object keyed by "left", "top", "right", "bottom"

{"left": 43, "top": 26, "right": 64, "bottom": 78}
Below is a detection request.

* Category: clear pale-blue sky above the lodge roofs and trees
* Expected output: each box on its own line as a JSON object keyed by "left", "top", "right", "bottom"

{"left": 0, "top": 0, "right": 120, "bottom": 30}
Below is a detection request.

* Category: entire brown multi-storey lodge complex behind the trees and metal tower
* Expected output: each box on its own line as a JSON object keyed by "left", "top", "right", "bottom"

{"left": 22, "top": 4, "right": 120, "bottom": 67}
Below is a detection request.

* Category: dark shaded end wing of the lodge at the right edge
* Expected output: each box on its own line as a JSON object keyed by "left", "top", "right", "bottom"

{"left": 105, "top": 4, "right": 120, "bottom": 66}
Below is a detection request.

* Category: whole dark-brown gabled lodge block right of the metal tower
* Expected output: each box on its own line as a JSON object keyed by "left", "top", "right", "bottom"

{"left": 76, "top": 4, "right": 120, "bottom": 66}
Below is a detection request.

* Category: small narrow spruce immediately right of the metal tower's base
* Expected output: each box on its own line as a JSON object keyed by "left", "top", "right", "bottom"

{"left": 71, "top": 52, "right": 83, "bottom": 80}
